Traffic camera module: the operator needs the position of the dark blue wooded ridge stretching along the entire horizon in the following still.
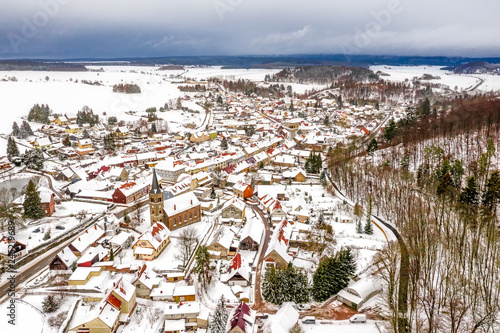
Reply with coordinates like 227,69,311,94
4,54,500,73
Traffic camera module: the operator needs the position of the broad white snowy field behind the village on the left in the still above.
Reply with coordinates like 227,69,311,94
0,66,278,133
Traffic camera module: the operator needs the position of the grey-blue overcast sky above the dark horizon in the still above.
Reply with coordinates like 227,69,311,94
0,0,500,58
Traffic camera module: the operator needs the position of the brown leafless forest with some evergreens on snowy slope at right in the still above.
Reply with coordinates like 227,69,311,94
329,96,500,332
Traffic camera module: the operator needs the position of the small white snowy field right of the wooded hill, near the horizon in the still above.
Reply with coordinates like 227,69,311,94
370,65,500,91
